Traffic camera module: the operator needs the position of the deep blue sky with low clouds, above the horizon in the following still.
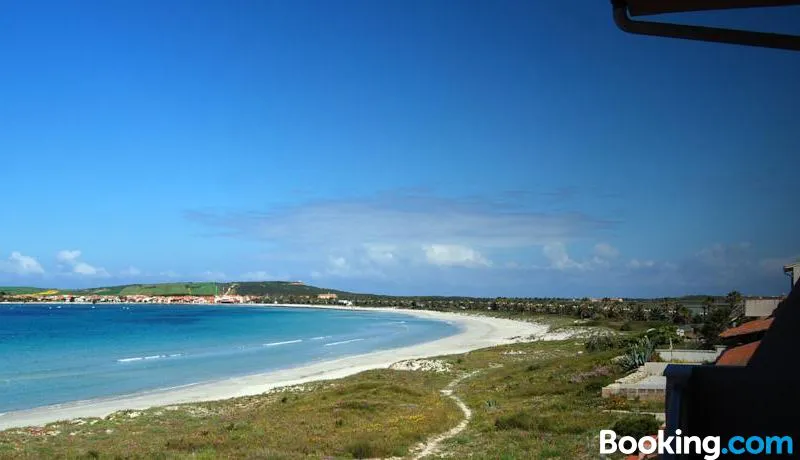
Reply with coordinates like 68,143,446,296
0,0,800,296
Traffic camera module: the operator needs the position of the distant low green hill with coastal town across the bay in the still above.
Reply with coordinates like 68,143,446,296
0,281,353,297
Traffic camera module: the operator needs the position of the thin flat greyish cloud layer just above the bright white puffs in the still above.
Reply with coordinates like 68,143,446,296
186,191,611,254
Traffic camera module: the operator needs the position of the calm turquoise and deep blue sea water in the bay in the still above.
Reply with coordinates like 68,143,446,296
0,304,458,412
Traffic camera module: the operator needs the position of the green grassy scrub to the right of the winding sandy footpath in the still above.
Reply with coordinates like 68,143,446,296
444,341,630,459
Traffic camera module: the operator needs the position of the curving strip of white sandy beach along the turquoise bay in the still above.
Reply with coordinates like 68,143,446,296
0,305,548,430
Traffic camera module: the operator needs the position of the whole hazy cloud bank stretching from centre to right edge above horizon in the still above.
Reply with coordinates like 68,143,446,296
181,194,797,295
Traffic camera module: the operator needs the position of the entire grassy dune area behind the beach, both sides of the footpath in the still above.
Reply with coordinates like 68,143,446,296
0,340,659,459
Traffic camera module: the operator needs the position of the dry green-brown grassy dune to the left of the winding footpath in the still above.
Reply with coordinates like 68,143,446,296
0,370,461,459
